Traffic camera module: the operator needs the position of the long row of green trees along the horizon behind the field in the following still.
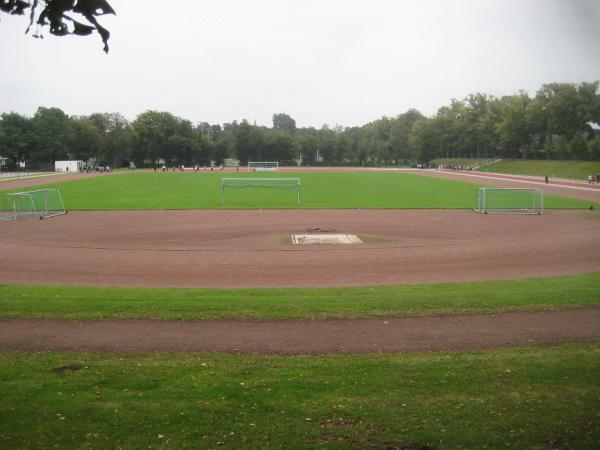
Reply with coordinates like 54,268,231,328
0,81,600,168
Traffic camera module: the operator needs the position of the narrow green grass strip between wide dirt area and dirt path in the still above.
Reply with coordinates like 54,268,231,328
0,273,600,320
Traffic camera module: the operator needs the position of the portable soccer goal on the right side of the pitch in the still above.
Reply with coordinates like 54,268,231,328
475,188,544,214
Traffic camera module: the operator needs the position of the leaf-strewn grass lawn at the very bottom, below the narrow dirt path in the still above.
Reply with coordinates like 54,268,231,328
0,344,600,449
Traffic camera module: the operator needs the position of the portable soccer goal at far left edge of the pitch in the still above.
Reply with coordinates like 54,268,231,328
0,189,67,220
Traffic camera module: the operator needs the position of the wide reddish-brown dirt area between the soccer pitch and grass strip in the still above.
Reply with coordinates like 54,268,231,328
0,210,600,287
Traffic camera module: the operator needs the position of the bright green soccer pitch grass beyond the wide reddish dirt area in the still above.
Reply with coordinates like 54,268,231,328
1,172,600,210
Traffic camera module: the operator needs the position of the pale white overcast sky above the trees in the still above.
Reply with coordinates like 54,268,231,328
0,0,600,127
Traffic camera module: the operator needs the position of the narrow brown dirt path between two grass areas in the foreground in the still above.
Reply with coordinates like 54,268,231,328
0,308,600,355
